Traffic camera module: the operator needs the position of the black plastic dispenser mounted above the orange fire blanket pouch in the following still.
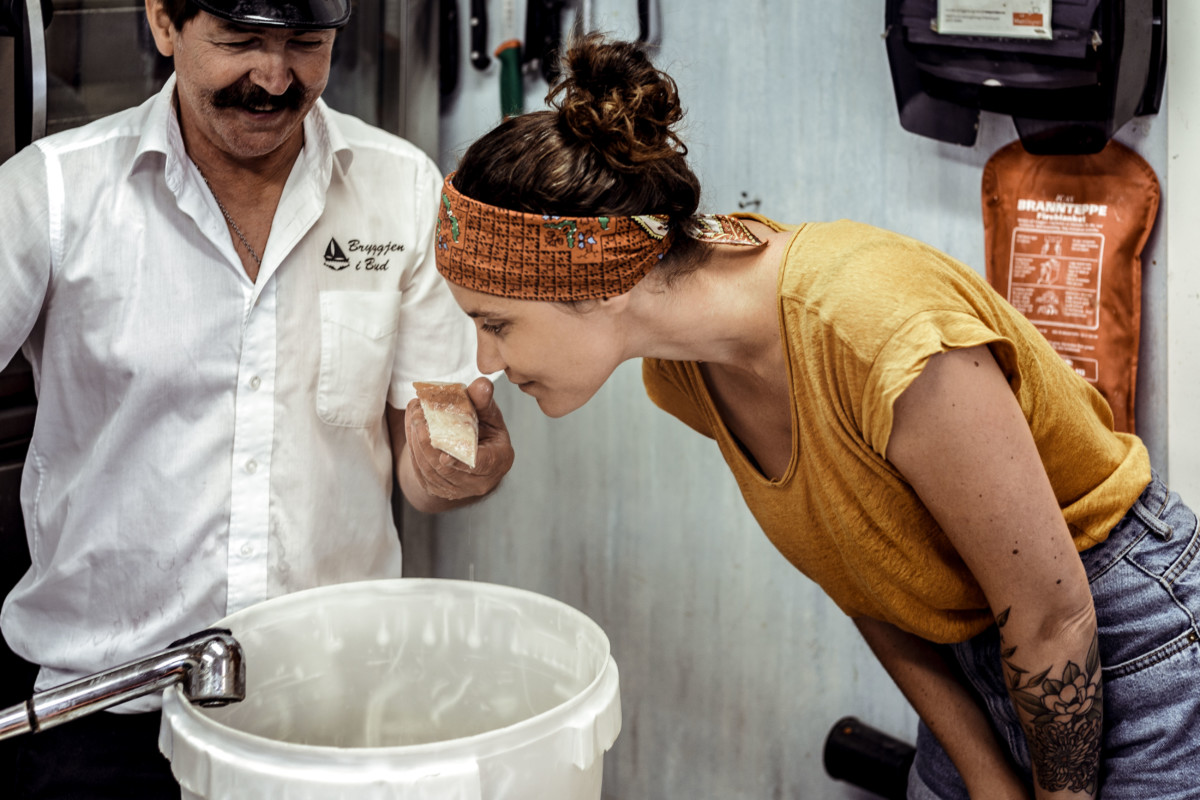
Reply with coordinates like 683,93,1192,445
884,0,1166,155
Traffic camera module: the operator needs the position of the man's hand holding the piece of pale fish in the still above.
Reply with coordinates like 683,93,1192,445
389,378,514,512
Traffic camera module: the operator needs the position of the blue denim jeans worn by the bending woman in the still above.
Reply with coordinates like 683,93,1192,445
908,475,1200,800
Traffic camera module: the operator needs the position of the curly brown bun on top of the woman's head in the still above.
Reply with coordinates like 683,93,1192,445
547,34,688,170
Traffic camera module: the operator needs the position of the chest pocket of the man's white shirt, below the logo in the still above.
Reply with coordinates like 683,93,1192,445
317,291,401,428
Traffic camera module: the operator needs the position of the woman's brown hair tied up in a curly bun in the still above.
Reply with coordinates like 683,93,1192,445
454,34,708,278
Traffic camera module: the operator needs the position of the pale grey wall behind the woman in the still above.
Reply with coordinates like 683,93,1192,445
404,0,1180,800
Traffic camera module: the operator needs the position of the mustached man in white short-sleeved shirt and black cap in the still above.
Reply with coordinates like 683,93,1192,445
0,0,512,798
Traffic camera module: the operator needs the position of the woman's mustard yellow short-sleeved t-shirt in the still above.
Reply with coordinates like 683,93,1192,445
642,217,1151,642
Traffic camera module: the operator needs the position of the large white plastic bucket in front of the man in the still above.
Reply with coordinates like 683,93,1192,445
160,578,620,800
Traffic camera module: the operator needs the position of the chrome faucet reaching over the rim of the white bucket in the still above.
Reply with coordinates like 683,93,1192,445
0,628,246,739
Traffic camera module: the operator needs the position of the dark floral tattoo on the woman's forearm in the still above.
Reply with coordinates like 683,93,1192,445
996,608,1103,794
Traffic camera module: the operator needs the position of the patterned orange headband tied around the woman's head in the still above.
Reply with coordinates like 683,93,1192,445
436,174,763,301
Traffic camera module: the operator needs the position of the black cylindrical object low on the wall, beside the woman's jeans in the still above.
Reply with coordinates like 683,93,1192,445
824,717,917,800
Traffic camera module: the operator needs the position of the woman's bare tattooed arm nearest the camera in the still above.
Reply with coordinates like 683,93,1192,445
887,347,1102,798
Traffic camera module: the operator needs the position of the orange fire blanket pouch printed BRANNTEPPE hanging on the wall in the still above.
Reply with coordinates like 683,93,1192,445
983,142,1159,433
